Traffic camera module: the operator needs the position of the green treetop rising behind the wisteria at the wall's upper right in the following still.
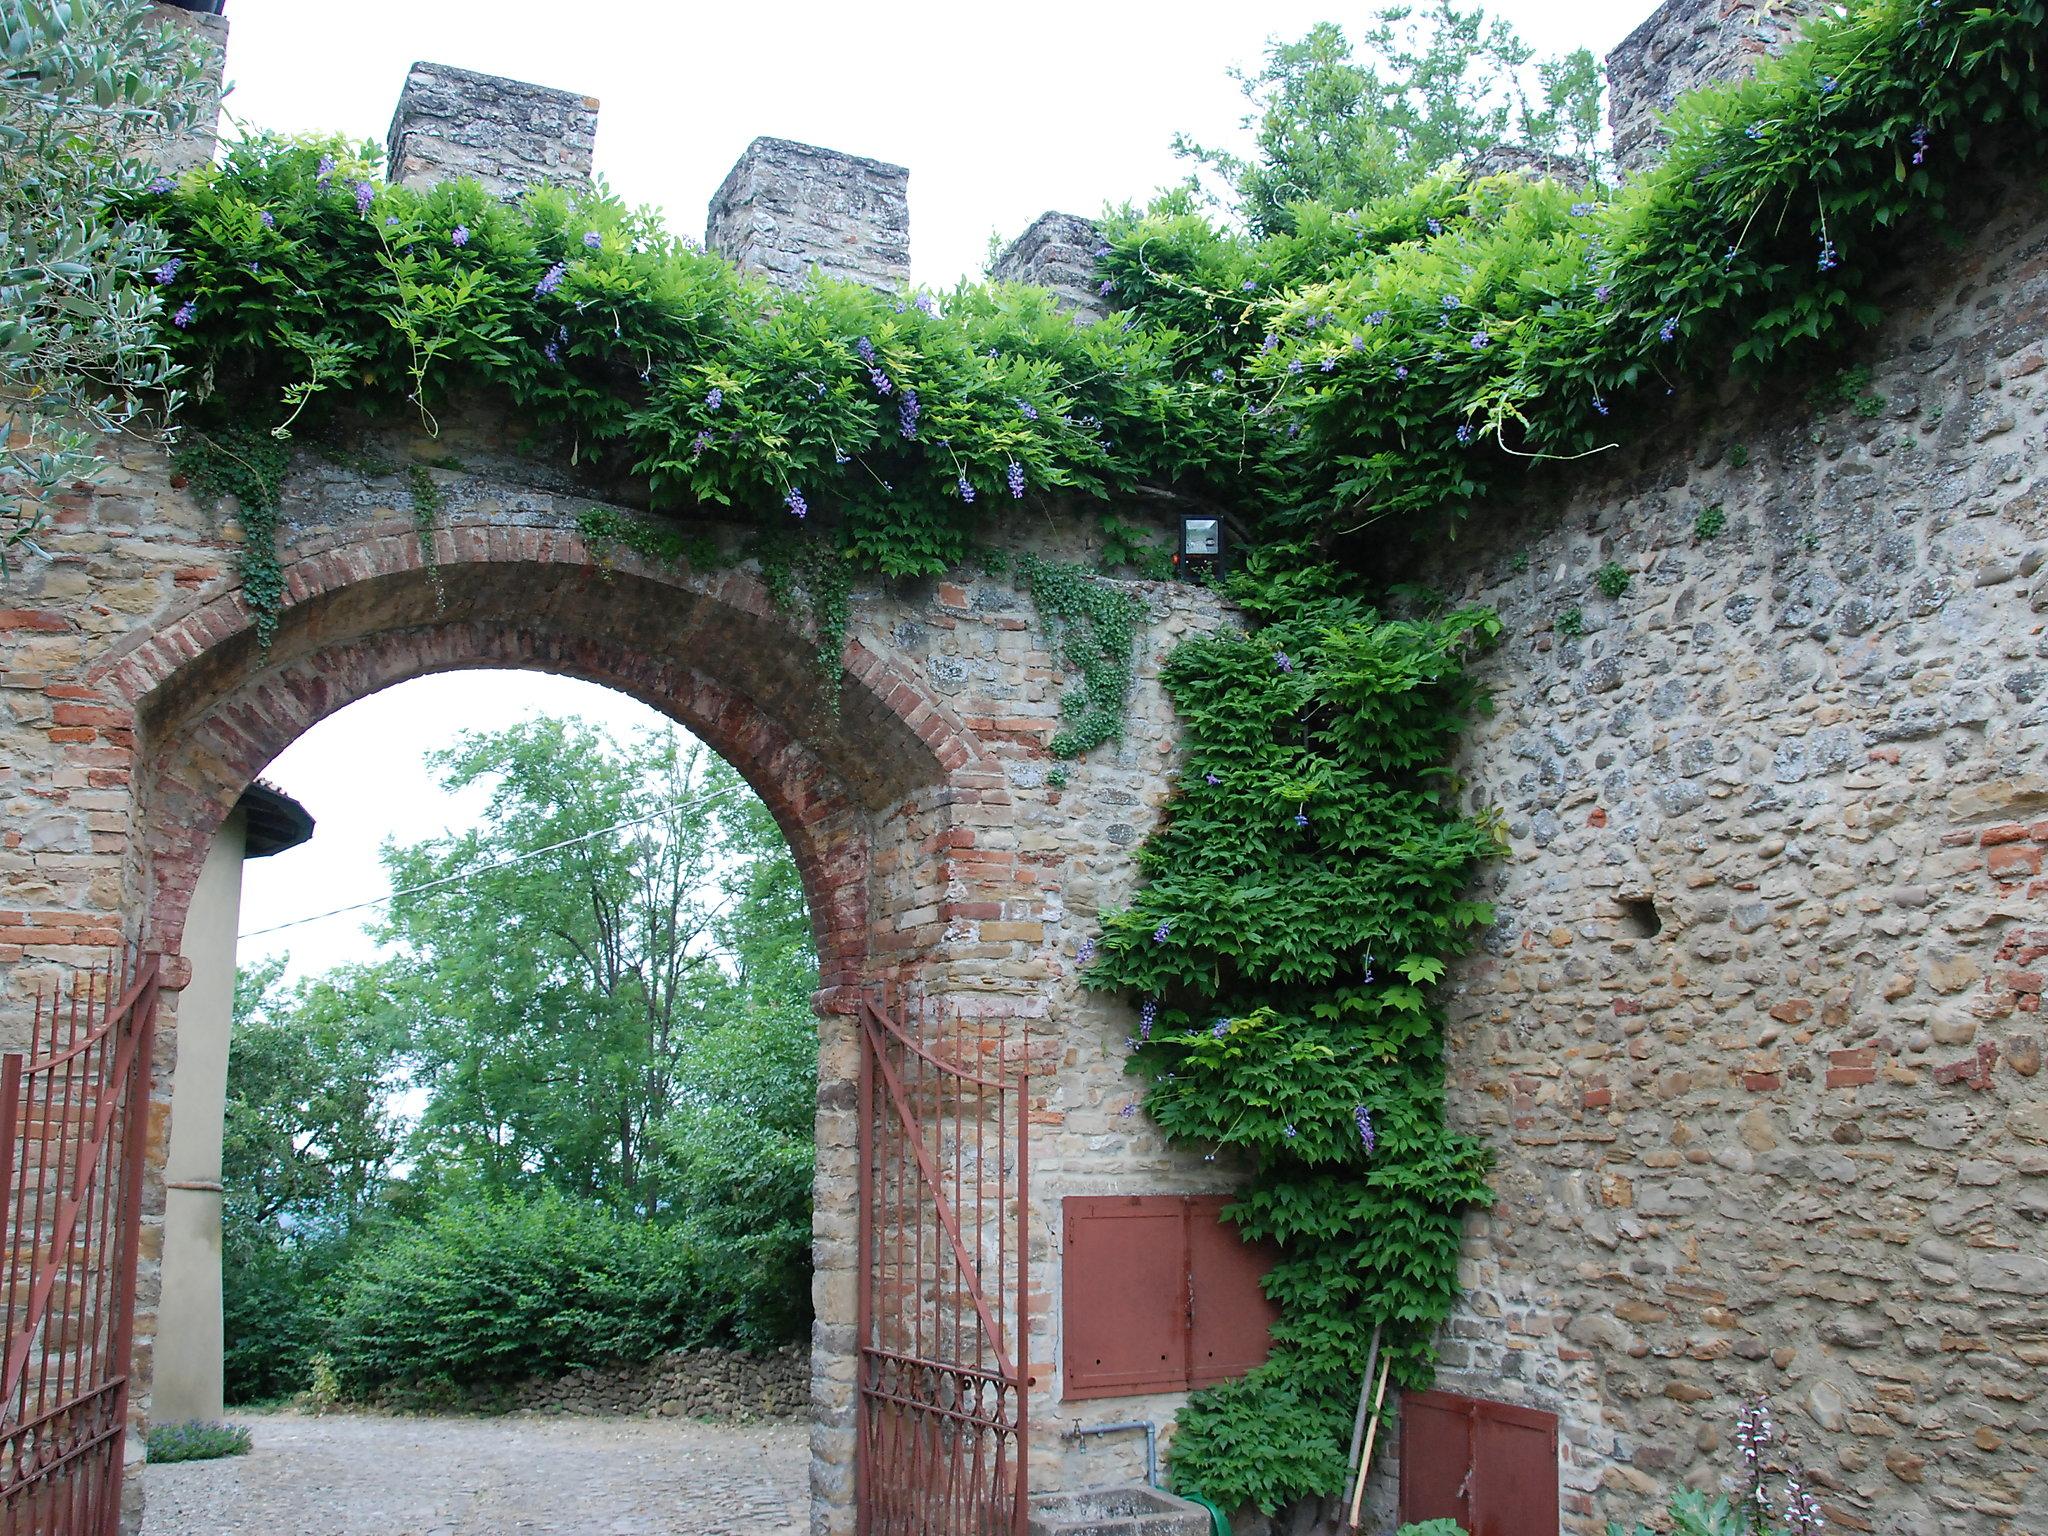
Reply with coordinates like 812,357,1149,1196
1174,0,1599,236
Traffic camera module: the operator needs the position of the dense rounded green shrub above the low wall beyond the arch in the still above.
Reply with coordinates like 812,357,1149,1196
330,1194,737,1393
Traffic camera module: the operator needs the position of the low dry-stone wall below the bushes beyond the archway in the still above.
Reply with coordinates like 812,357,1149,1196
504,1348,811,1419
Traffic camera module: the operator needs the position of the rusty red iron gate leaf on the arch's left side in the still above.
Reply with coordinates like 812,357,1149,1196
0,950,158,1536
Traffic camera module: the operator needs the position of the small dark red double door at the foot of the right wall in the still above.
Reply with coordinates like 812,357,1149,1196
1401,1393,1559,1536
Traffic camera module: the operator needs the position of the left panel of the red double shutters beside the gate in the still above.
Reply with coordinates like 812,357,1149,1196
1061,1194,1188,1397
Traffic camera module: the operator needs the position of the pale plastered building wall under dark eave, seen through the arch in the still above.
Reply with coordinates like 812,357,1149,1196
150,809,248,1423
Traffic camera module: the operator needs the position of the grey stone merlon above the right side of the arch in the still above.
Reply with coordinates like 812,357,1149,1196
705,139,909,291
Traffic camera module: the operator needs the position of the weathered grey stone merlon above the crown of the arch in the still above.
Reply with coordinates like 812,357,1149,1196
385,63,598,203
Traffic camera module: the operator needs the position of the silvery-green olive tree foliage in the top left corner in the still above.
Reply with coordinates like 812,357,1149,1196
0,0,219,565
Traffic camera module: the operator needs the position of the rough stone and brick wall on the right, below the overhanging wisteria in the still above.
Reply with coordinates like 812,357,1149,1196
1409,180,2048,1536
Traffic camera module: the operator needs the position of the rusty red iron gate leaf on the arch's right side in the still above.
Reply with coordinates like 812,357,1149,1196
856,999,1030,1536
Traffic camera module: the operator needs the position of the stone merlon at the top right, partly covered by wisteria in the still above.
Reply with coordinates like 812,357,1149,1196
1608,0,1823,172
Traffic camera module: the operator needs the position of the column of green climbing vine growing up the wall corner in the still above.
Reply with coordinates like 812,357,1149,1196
1085,584,1501,1511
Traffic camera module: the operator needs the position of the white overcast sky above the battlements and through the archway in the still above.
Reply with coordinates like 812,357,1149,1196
227,0,1653,975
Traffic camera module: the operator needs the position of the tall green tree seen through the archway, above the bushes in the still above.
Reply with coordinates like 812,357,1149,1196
385,721,815,1217
